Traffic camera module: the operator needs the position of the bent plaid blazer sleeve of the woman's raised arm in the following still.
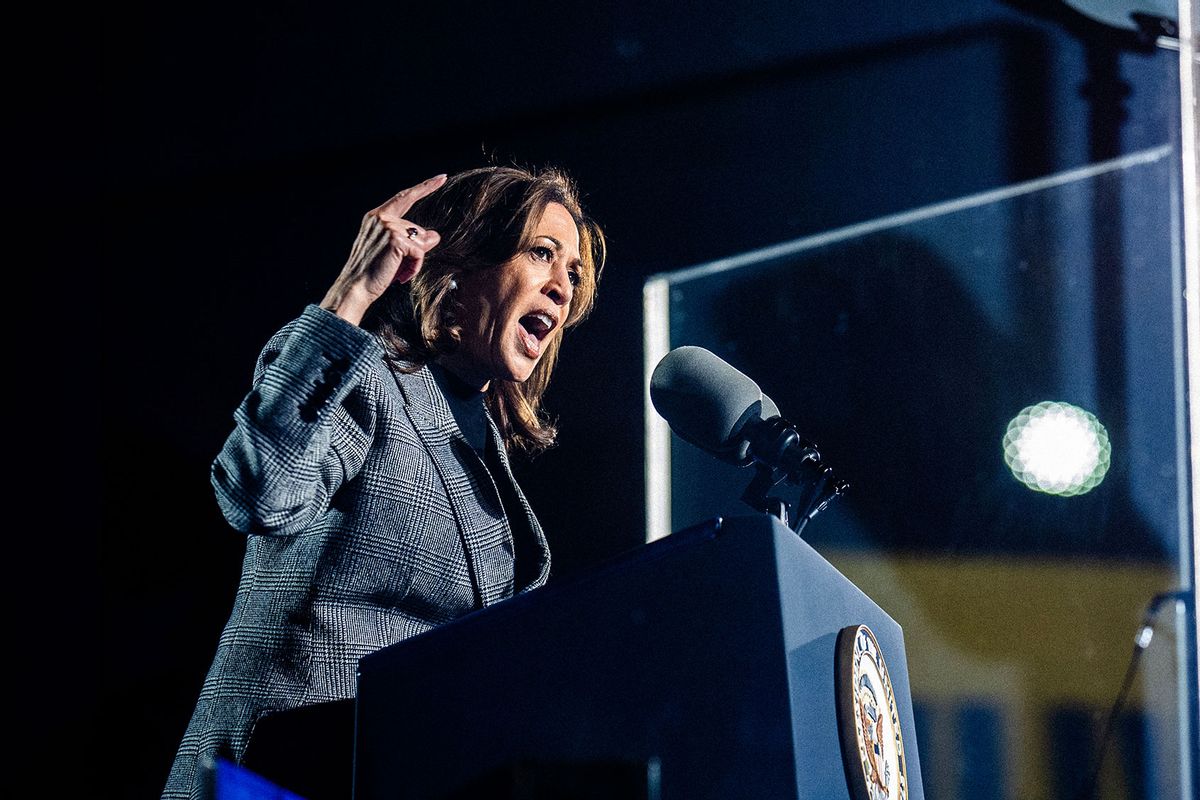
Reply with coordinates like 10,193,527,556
211,305,383,536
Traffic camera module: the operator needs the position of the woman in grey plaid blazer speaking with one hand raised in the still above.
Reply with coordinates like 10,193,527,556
163,167,605,798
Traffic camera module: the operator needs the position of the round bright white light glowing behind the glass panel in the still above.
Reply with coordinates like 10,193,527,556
1004,401,1112,497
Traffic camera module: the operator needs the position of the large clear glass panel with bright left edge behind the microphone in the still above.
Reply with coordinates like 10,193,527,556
646,148,1195,800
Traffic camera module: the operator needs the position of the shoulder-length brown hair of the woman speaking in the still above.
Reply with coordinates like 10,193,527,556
362,167,606,456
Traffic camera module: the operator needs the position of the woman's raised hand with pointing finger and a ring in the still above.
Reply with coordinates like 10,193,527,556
320,175,446,325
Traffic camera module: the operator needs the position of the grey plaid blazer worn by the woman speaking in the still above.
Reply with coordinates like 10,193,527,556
162,306,550,798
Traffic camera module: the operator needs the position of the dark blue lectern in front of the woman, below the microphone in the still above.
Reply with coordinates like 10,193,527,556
354,516,924,800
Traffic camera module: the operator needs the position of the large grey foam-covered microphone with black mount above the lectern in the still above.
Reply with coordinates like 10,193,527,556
650,345,821,475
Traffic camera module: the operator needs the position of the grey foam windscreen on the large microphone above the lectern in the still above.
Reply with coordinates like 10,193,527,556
650,345,763,464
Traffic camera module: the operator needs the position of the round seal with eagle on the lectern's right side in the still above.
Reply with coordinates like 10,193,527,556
834,625,908,800
